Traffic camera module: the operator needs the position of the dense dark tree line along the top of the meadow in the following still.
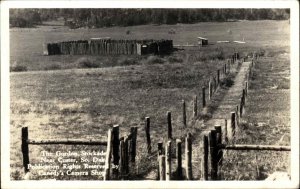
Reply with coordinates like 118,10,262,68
10,9,290,28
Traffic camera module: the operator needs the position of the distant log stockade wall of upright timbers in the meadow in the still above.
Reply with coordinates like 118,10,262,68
43,39,173,55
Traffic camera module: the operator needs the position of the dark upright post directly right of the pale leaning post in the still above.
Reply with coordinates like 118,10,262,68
112,125,120,178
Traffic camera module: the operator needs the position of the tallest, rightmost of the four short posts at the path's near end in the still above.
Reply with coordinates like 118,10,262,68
185,133,193,180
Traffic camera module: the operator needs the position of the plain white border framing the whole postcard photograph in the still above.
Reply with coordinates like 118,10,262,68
1,0,299,189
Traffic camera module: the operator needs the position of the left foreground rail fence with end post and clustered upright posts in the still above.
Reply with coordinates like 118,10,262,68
21,125,137,180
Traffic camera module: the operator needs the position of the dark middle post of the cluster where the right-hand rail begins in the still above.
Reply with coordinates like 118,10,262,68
208,130,218,180
